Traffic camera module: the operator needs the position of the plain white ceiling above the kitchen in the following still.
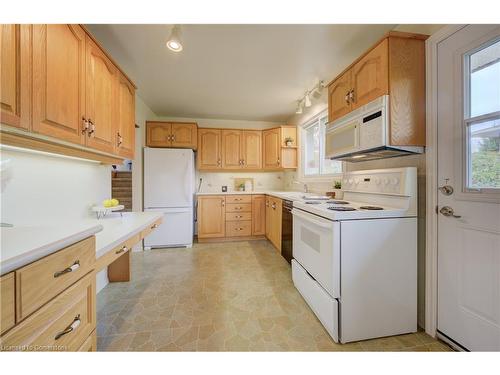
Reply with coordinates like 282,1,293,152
88,25,395,121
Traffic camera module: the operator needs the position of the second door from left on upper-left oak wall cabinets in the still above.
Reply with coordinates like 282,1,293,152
32,24,86,144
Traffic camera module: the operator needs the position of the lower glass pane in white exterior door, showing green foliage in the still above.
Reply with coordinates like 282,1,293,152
467,118,500,189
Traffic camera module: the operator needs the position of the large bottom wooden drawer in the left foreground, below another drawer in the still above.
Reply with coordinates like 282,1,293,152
0,272,96,351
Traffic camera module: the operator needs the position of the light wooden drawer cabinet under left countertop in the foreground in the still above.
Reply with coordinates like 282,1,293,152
0,236,96,351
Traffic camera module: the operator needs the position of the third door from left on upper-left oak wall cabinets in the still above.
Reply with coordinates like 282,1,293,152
85,36,118,153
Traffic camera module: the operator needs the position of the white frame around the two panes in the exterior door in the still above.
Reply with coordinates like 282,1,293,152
462,38,500,195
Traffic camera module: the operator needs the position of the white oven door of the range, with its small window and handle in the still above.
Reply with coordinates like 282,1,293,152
292,209,340,298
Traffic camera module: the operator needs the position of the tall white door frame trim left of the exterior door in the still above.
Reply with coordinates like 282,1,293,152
425,25,467,337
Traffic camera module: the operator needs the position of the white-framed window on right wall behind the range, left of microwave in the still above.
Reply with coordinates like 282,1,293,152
300,111,342,177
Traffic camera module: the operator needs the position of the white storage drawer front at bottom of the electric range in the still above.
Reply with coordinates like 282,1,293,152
292,259,339,342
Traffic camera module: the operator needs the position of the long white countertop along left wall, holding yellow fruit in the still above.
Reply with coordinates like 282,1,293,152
0,212,162,275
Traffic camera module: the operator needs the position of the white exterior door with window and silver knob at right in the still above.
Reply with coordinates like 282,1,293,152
437,25,500,351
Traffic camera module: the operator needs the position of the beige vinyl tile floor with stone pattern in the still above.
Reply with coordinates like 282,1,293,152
97,241,451,351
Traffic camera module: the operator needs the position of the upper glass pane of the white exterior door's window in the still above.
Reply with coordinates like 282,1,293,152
469,40,500,117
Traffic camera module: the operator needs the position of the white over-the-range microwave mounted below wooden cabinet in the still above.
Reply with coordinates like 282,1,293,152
325,95,424,162
